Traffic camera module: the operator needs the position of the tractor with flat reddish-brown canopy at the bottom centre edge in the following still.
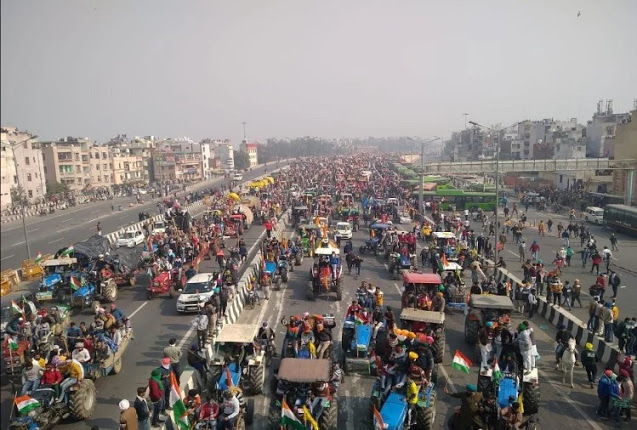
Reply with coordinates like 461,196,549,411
267,358,338,430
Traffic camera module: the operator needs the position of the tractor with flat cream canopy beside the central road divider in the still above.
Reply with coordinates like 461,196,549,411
208,324,266,399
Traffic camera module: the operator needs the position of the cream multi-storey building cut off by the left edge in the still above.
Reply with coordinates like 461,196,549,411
0,127,46,208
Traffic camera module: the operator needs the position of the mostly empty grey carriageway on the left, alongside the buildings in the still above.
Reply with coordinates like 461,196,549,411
0,162,284,270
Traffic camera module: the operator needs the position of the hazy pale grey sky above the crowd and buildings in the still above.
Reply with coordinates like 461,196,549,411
1,0,637,143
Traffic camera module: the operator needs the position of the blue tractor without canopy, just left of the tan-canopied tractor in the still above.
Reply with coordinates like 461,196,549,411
341,316,375,375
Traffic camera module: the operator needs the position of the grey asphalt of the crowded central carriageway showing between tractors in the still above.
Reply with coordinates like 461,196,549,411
227,220,607,430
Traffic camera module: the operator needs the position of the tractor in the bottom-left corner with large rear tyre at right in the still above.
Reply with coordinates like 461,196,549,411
8,379,97,430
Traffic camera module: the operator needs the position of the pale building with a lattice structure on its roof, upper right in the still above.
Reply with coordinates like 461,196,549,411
586,100,630,158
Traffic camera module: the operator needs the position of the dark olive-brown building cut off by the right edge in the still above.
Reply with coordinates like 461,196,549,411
613,110,637,205
